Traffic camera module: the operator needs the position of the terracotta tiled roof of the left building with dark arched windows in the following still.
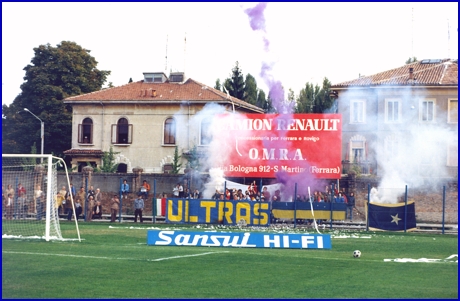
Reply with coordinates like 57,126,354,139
64,78,263,113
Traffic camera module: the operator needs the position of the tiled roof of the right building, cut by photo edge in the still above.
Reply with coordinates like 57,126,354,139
331,59,458,88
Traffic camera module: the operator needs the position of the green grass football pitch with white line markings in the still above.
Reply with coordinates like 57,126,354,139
2,222,458,299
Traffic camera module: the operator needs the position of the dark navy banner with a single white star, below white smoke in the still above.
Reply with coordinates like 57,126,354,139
368,201,417,231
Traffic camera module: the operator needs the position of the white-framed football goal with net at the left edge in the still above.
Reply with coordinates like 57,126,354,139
2,154,80,241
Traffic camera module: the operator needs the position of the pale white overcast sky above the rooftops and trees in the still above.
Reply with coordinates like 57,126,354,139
2,2,458,105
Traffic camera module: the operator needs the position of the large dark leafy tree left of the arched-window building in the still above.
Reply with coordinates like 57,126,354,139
2,41,110,157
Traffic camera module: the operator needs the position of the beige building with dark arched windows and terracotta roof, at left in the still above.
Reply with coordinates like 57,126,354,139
64,72,263,173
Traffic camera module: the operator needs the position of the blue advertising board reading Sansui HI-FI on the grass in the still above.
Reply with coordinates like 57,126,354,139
147,230,332,249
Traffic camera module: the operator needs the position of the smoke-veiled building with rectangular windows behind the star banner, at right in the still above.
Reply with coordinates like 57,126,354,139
331,59,458,179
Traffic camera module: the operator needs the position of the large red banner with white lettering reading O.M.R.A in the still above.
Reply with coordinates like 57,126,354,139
213,114,342,179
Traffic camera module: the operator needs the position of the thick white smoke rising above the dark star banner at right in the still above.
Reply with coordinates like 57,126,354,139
339,83,458,203
